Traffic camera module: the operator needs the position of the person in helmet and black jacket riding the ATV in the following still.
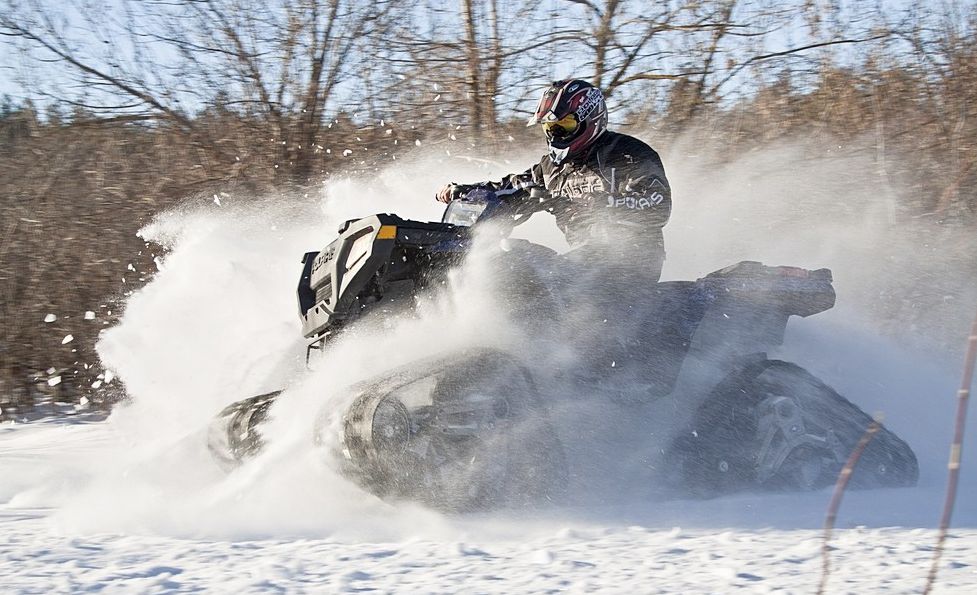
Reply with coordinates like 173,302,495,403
437,79,672,283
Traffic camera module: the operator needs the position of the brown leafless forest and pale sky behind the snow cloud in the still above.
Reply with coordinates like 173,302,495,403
0,0,977,417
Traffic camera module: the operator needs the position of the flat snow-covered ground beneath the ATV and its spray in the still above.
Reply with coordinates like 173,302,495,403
0,422,977,593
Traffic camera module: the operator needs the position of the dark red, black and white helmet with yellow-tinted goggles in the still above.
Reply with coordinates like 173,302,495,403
527,79,607,165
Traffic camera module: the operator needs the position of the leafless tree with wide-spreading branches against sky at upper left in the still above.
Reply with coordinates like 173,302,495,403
0,0,391,181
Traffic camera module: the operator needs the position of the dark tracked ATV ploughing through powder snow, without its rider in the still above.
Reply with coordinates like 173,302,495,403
209,191,918,510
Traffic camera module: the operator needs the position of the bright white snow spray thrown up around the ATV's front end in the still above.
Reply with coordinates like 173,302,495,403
49,150,548,538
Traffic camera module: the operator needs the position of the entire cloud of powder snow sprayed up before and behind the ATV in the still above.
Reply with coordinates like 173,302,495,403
36,140,977,540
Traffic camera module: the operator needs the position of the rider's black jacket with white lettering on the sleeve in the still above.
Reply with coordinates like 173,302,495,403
485,131,672,258
